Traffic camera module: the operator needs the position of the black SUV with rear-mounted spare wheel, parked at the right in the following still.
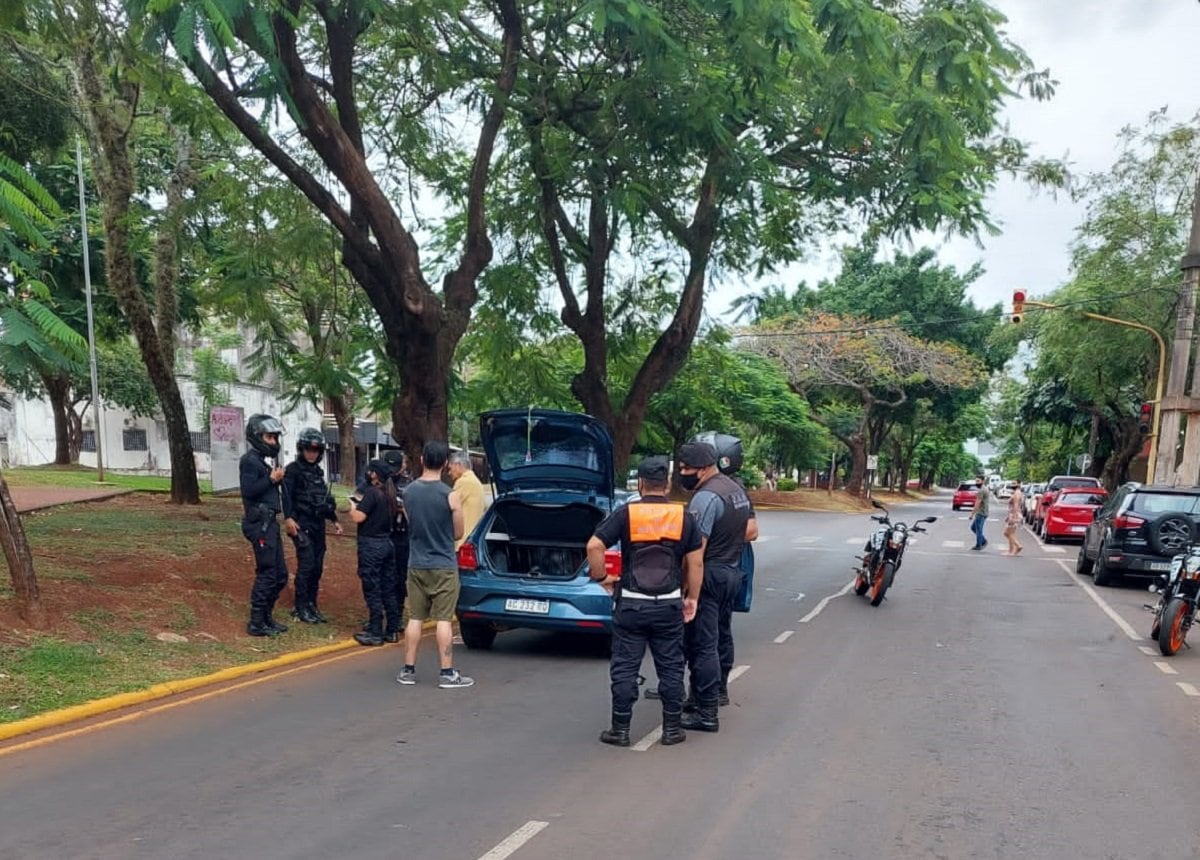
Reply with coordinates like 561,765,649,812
1075,483,1200,585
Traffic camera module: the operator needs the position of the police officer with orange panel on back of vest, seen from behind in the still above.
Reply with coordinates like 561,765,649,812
587,457,703,746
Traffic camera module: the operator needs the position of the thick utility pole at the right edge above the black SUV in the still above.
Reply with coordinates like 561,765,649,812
1156,176,1200,487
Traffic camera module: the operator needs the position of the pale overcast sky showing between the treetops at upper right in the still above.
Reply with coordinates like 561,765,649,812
708,0,1200,317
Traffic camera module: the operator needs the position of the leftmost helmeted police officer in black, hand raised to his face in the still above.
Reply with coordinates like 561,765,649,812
238,415,288,636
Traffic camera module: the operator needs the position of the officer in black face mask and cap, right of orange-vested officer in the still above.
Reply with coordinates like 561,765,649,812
676,441,750,732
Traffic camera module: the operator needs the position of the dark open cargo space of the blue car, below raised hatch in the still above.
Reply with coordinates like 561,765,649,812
482,499,605,579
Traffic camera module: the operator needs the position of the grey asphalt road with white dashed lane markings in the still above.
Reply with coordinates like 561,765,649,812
0,497,1200,860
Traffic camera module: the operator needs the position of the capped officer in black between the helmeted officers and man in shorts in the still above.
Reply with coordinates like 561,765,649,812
350,459,400,645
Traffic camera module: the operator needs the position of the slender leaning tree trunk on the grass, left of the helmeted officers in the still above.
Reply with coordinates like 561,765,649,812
76,44,200,505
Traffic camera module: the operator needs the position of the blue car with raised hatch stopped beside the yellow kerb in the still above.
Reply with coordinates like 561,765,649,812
457,409,625,649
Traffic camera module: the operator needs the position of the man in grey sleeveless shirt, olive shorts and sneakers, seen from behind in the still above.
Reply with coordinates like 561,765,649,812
396,441,475,690
